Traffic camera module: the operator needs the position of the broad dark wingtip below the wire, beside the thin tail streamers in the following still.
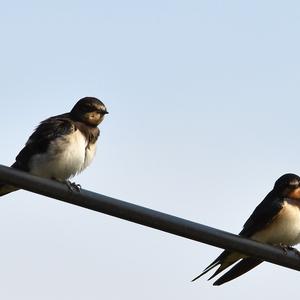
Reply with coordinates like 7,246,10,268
213,257,263,285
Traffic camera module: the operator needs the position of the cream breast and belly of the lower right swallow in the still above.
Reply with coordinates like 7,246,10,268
251,200,300,246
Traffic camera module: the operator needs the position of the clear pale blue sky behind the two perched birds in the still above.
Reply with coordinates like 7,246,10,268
0,0,300,300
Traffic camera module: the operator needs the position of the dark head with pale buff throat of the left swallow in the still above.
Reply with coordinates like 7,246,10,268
71,97,108,126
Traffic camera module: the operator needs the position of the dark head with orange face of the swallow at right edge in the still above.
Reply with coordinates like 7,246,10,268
273,173,300,200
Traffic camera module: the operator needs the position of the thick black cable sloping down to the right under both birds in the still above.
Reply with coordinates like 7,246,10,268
0,165,300,271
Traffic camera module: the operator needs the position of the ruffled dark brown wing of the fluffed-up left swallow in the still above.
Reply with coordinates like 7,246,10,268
12,114,76,171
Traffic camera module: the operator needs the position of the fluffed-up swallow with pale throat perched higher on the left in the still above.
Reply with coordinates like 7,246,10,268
0,97,108,196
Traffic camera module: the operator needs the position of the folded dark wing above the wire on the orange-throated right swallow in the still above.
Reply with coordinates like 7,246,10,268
240,191,283,237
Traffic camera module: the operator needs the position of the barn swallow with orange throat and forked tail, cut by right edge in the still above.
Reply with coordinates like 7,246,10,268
192,174,300,285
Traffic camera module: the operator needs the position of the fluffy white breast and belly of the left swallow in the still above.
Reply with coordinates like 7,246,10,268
30,130,96,181
